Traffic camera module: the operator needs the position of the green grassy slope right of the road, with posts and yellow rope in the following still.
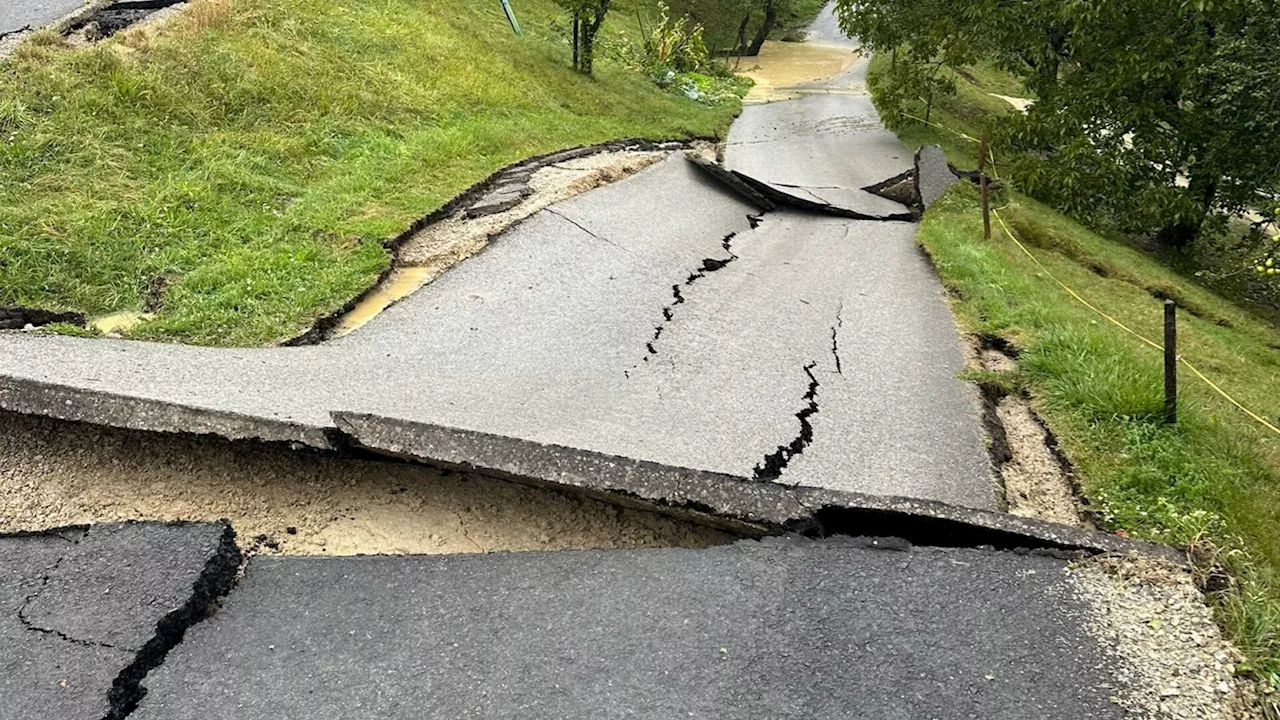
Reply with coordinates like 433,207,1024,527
873,51,1280,697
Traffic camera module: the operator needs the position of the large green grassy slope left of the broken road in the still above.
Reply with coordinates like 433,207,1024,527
0,0,737,345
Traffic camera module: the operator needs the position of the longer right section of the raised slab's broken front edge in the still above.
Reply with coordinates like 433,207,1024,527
333,413,1185,564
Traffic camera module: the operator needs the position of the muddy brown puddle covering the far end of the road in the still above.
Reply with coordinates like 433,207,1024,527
739,40,859,102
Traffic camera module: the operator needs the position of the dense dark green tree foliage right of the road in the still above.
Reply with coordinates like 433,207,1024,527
838,0,1280,247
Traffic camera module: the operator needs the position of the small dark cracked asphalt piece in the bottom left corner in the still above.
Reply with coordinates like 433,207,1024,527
0,523,239,720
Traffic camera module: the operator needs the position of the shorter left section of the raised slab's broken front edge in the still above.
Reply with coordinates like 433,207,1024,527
0,375,342,450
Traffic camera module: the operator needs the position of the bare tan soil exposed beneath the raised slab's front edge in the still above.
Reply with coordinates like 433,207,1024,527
0,413,735,555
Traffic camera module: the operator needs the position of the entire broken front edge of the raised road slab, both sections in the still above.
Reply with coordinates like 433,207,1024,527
0,375,1185,564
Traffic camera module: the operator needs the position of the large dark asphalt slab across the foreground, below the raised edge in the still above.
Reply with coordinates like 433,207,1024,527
133,538,1123,720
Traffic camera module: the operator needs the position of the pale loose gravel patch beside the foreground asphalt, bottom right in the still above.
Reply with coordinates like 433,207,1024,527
1070,556,1262,720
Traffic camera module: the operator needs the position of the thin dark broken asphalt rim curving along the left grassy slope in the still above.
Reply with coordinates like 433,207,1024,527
279,136,717,347
